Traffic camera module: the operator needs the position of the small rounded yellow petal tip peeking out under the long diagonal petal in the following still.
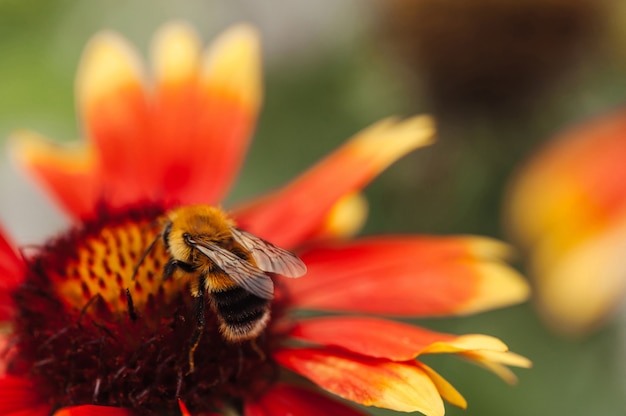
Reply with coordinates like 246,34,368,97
319,193,368,238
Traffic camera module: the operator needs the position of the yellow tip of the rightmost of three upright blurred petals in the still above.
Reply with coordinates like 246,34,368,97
202,24,263,113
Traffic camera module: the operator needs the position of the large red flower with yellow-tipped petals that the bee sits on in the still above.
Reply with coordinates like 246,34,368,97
0,23,529,416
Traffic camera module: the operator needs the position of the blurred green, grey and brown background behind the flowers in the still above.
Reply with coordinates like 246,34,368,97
0,0,626,416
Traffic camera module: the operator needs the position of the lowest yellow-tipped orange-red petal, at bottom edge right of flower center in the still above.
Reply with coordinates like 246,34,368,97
275,348,444,416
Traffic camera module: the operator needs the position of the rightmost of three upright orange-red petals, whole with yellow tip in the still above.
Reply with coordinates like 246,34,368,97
170,25,263,204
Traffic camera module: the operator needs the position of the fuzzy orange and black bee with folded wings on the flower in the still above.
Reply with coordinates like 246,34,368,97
135,205,306,372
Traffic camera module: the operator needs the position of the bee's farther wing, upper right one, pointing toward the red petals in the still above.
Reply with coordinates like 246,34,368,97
231,227,306,277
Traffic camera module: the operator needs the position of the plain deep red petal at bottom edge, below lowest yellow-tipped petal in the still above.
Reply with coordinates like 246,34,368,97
244,384,365,416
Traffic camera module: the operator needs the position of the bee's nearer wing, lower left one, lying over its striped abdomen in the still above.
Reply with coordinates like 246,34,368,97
190,240,274,299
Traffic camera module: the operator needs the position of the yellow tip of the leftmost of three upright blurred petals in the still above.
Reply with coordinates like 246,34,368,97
76,31,145,113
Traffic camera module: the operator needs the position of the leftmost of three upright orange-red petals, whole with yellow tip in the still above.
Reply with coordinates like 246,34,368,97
76,28,149,214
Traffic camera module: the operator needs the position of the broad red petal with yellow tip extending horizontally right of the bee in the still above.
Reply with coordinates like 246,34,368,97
284,237,529,316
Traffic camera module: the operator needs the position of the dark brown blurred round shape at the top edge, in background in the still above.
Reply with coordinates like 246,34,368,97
378,0,604,118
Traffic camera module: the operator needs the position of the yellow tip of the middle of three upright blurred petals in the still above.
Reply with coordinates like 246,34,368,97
151,22,201,83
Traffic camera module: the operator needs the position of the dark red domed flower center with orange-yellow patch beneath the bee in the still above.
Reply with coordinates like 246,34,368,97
9,207,282,413
